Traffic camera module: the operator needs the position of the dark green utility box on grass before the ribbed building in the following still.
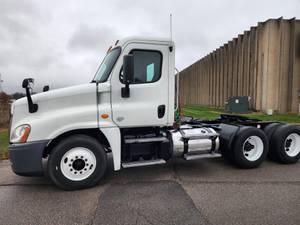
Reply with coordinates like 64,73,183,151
225,96,250,113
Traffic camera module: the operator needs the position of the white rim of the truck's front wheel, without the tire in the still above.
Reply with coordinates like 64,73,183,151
60,147,96,181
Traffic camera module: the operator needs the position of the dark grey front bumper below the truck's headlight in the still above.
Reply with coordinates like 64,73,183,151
9,140,49,176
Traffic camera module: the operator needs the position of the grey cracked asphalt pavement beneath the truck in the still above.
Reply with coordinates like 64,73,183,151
0,158,300,225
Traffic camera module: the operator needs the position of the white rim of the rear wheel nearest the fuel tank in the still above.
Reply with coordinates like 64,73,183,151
243,136,264,162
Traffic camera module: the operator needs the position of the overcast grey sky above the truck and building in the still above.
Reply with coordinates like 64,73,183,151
0,0,300,93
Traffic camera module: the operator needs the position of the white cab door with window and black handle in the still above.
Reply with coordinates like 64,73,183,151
111,43,169,127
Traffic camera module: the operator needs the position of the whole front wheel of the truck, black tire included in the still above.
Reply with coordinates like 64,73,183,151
47,135,107,191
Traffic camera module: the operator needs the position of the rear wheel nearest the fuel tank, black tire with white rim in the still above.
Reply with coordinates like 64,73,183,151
232,127,269,169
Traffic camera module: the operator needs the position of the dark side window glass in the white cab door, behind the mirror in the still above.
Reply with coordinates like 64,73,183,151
120,50,162,84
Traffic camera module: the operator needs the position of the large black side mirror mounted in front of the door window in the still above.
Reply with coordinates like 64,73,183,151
121,55,134,98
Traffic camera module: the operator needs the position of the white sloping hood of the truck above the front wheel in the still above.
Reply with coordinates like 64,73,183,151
11,82,110,141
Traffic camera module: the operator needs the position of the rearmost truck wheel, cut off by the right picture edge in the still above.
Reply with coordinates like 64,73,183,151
270,125,300,164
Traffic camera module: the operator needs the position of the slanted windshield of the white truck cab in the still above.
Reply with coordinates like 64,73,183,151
93,47,121,83
